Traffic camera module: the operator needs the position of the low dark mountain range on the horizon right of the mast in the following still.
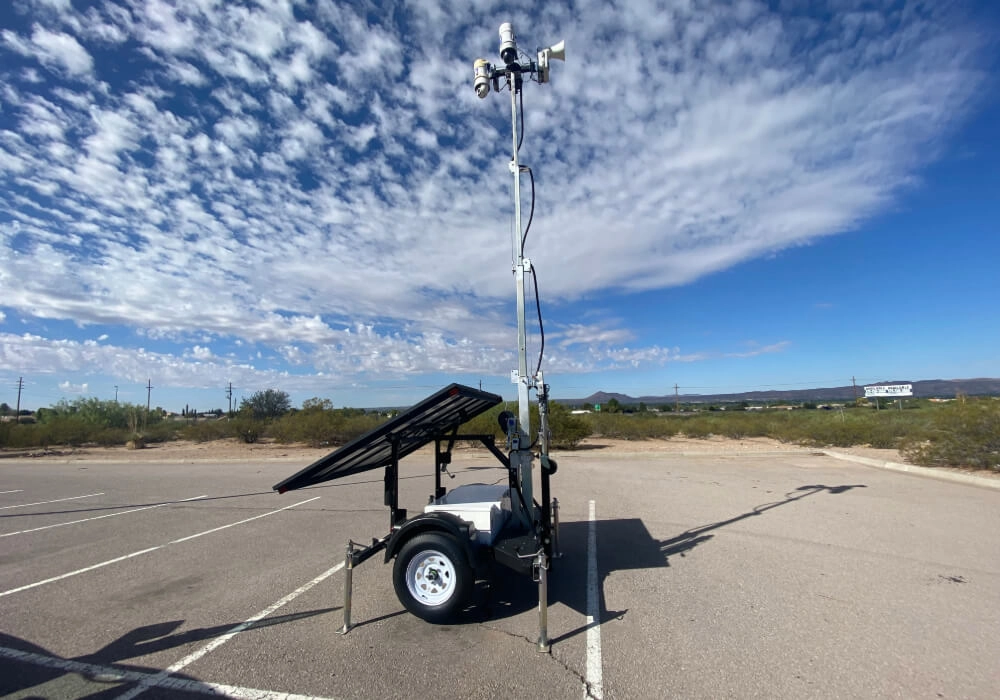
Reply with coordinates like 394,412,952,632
558,379,1000,406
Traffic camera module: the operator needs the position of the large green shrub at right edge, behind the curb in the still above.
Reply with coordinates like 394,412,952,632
903,399,1000,470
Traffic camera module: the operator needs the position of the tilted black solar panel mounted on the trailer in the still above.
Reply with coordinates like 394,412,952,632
274,384,503,493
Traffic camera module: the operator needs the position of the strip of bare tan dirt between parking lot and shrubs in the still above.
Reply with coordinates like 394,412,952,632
0,437,905,464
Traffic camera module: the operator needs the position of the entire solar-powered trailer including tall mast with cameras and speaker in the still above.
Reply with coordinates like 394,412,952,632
274,23,566,652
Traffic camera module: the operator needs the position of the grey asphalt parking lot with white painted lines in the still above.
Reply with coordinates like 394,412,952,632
0,449,1000,698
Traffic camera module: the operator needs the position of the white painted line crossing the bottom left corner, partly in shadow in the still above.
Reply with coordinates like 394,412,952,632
0,647,329,700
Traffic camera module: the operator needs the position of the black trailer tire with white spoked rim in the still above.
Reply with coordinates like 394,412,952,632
392,532,474,623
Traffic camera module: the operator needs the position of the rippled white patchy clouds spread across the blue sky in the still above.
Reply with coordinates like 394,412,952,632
0,0,983,388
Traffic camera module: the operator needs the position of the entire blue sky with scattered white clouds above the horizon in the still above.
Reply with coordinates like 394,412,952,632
0,0,1000,410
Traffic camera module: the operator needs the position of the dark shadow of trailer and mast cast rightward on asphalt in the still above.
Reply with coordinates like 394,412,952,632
458,484,867,642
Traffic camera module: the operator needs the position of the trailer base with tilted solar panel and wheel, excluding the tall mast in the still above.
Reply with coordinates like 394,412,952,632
274,384,555,644
